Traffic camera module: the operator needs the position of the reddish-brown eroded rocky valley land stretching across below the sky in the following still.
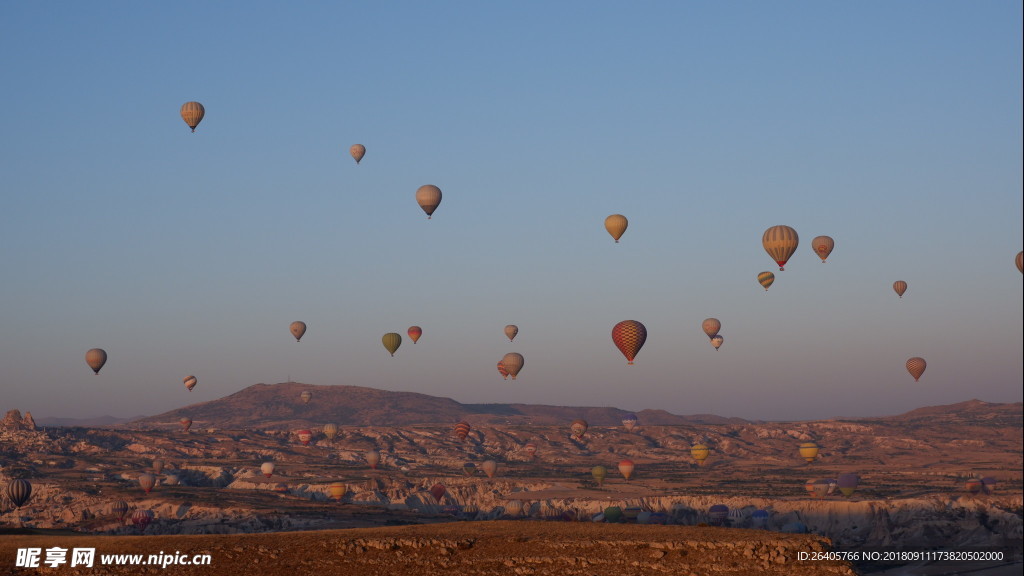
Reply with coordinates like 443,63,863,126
0,383,1024,574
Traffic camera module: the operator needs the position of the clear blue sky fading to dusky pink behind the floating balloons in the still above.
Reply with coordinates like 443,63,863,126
0,0,1024,420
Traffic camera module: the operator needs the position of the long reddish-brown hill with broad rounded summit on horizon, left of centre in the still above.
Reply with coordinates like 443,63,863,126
132,382,746,428
